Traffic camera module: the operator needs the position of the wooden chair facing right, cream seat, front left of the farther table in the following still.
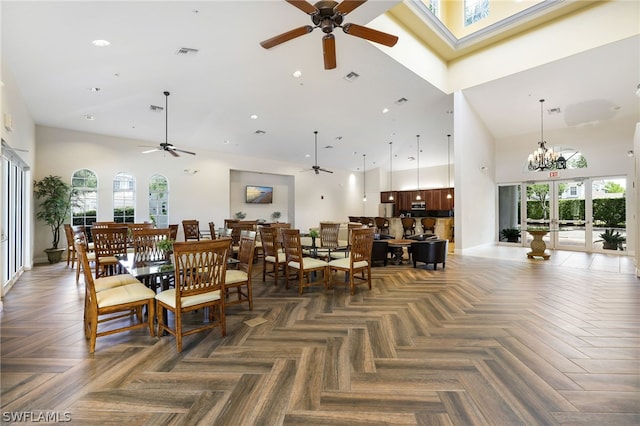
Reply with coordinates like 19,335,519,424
281,229,329,295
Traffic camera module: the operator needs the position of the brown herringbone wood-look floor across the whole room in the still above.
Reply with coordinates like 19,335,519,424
1,255,640,425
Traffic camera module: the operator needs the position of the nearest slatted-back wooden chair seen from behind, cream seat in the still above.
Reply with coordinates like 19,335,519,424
156,239,229,352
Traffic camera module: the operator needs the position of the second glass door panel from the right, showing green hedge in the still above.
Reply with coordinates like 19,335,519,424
550,179,591,251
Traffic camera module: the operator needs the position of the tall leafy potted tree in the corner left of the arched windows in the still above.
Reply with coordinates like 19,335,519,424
33,175,75,263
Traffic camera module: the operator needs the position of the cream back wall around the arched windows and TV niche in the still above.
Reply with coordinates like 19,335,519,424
33,126,364,261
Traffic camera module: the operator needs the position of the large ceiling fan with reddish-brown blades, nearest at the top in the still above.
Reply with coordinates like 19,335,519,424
260,0,398,70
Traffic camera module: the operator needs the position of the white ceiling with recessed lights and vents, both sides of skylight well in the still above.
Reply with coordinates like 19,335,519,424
1,0,640,170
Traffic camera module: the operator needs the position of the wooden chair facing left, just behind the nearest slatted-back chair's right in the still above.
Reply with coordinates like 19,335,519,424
224,235,256,311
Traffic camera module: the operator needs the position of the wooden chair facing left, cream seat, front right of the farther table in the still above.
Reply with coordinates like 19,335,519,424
329,228,373,296
